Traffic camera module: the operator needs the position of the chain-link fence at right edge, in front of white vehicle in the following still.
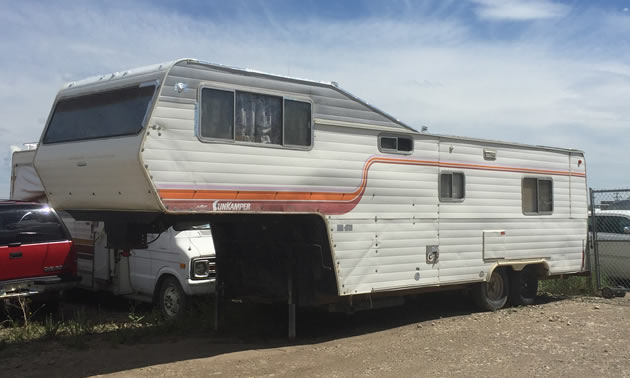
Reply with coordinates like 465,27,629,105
589,189,630,297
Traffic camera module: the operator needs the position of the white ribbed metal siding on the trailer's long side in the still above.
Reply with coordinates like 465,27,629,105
142,65,586,295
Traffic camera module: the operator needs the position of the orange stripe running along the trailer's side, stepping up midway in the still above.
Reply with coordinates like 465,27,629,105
158,157,586,201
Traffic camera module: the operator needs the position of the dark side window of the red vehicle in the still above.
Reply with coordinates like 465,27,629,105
0,205,67,245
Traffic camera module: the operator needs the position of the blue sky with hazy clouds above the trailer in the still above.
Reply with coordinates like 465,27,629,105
0,0,630,198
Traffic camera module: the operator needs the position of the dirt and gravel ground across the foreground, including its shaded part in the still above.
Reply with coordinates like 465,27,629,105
0,295,630,377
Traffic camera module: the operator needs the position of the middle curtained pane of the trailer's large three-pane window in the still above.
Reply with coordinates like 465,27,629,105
234,92,282,144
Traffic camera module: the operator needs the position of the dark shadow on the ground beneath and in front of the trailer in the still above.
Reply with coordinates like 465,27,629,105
0,292,562,377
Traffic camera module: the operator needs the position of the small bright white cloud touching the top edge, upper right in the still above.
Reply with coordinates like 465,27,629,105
472,0,569,21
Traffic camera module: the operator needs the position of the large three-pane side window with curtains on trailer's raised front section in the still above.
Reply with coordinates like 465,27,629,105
199,88,313,147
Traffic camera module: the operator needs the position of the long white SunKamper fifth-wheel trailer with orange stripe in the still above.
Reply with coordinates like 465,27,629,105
35,59,587,334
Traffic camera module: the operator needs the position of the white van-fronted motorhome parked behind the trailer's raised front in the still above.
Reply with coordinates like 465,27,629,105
11,149,215,318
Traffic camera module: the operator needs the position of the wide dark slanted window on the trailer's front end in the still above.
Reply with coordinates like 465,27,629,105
43,85,155,144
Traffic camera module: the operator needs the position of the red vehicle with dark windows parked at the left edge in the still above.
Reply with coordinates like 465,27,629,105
0,200,78,299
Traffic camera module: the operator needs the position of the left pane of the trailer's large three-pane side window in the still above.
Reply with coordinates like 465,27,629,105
201,88,234,139
